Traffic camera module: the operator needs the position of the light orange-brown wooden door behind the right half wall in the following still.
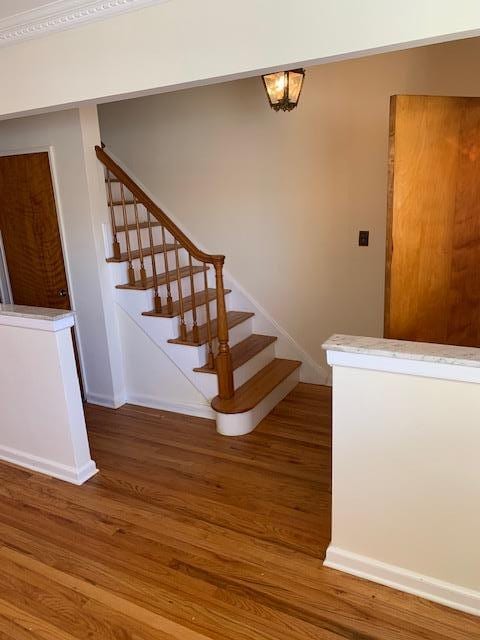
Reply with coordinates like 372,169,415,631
385,96,480,347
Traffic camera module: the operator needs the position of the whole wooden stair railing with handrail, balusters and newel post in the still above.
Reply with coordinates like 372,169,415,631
95,146,234,400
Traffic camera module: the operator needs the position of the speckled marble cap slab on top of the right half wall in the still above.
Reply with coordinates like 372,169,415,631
322,334,480,368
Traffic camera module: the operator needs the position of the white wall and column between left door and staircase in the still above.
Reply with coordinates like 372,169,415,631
0,107,124,404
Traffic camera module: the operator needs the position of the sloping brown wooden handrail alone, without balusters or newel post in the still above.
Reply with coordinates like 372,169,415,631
95,145,225,265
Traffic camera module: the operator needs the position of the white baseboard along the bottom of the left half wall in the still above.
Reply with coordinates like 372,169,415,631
0,446,98,485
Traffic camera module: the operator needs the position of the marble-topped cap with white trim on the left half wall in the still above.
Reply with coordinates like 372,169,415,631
0,304,75,332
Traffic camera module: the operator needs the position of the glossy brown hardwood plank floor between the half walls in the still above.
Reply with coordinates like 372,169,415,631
0,384,480,640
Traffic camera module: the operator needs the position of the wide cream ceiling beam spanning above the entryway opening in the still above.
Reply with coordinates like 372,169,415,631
0,0,480,115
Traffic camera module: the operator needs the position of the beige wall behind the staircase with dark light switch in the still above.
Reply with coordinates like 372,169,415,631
100,39,480,370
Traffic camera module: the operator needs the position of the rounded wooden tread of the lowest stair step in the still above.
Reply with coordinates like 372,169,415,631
212,358,302,413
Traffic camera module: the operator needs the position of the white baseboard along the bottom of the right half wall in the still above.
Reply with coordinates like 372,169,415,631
324,545,480,616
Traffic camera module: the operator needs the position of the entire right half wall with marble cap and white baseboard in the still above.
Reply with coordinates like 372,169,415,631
324,336,480,615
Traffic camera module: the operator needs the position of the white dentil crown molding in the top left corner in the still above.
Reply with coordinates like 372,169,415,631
0,0,168,47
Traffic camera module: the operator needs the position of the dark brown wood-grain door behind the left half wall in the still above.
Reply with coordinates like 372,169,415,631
0,153,70,309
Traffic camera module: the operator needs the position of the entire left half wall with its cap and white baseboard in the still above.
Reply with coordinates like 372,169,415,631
0,304,97,484
